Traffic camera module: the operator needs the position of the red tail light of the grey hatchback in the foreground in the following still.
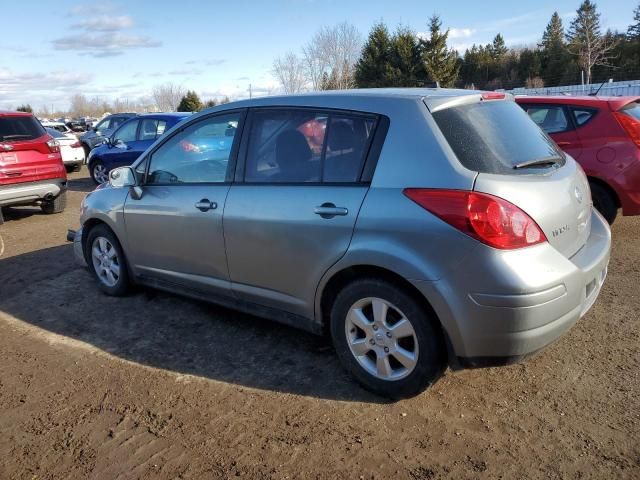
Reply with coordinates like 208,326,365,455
404,188,547,250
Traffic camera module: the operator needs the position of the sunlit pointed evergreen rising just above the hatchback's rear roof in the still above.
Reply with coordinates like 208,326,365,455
420,15,460,87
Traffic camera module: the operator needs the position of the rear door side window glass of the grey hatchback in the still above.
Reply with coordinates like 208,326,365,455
245,109,376,183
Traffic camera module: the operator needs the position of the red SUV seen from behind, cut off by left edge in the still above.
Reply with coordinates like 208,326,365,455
0,111,67,221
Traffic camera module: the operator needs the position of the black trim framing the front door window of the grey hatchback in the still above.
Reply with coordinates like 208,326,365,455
138,108,247,187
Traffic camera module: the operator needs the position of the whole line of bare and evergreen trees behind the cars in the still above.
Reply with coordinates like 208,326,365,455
272,0,640,93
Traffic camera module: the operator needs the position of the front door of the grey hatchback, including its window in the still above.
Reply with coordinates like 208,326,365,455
124,112,243,294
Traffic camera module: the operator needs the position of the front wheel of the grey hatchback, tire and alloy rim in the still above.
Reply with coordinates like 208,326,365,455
84,225,131,297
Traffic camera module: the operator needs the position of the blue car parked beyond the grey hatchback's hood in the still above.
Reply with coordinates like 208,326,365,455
87,113,191,184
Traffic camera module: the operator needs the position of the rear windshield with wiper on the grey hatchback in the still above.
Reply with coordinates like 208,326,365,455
433,101,565,174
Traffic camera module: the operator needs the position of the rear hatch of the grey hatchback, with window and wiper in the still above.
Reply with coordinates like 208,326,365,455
426,93,591,257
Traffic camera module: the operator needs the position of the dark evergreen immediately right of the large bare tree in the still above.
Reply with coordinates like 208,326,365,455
355,22,391,88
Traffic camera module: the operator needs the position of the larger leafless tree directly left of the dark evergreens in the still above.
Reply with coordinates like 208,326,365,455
302,22,362,90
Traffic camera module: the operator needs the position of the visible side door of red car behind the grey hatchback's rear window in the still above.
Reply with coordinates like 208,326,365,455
522,103,582,160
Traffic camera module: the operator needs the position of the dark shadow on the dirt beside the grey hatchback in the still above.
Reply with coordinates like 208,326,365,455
0,245,386,403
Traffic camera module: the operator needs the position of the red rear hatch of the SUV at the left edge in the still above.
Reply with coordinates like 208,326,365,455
0,113,66,185
